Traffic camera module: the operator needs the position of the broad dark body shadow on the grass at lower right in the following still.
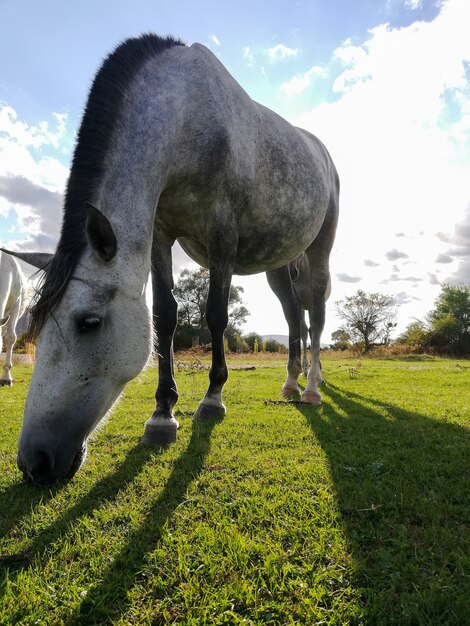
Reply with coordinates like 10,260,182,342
297,385,470,625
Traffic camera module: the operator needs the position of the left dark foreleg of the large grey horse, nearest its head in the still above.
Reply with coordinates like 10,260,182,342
143,236,179,445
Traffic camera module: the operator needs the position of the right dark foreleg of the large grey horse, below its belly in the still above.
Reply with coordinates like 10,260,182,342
194,269,232,419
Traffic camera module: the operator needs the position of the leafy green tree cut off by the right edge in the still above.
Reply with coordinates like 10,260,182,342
428,285,470,356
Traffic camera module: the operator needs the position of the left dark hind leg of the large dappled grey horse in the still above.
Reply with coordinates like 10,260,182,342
266,265,302,398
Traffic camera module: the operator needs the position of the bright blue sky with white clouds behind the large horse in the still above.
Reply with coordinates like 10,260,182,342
0,0,470,340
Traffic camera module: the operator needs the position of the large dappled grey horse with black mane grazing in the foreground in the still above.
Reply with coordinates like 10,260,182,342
6,35,339,481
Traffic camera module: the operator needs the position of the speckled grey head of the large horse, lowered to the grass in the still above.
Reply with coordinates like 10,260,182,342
18,208,151,482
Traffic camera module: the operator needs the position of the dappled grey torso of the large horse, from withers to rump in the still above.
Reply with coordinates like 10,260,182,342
157,44,332,274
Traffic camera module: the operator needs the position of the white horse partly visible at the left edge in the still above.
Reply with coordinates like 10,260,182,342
0,251,26,386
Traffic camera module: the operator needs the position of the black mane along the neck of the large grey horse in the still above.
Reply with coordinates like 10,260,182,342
29,34,185,340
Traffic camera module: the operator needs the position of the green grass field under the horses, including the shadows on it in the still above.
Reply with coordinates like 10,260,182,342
0,357,470,626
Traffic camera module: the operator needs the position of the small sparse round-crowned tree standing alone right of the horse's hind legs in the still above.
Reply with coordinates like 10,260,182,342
336,289,397,352
